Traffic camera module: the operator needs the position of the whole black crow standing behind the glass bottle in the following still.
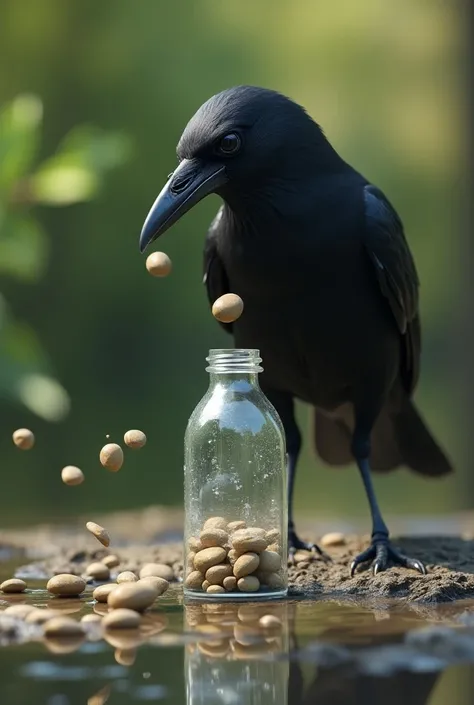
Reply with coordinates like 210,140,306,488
140,86,452,575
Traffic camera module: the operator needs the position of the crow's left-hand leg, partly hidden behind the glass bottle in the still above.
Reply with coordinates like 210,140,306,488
265,390,331,560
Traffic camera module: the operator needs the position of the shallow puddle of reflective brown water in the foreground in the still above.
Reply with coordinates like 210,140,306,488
0,564,474,705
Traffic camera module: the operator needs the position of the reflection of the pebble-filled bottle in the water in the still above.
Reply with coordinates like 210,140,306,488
185,603,289,705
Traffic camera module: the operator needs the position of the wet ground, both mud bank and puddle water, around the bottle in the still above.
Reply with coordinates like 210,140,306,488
0,508,474,705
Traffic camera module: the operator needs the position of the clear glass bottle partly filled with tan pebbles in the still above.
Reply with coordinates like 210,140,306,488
184,349,288,600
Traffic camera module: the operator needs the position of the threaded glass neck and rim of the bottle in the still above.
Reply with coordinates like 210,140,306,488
206,348,263,387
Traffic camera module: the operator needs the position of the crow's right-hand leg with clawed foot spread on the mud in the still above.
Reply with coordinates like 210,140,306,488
351,426,426,575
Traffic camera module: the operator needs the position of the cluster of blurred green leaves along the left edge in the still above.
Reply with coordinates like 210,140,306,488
0,95,131,421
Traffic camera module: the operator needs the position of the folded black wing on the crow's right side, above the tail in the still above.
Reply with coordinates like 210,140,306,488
364,184,421,393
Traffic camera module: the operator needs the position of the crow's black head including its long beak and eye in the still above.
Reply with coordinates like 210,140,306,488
140,86,328,252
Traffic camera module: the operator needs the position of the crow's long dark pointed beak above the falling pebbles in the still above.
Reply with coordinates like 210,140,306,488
140,159,227,252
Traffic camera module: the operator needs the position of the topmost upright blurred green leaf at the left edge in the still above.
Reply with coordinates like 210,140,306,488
0,94,43,191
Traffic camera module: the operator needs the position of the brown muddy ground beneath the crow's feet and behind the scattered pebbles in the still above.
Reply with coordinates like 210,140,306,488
0,507,474,602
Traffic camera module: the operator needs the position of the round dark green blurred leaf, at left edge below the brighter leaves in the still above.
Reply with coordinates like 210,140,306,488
0,212,49,282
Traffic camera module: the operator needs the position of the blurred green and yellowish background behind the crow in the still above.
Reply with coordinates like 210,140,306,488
0,0,466,525
